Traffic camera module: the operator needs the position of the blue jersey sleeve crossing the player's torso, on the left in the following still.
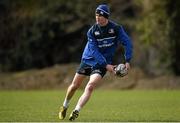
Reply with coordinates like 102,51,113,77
87,29,107,67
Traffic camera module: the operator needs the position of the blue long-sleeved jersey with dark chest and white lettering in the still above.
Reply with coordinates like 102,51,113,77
81,21,132,67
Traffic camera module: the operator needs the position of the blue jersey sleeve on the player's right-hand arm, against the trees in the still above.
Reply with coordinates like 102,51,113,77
118,26,133,62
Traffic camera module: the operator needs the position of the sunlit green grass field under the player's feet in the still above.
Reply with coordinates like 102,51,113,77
0,90,180,122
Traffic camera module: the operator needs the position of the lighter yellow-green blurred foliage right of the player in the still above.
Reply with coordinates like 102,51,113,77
136,0,172,74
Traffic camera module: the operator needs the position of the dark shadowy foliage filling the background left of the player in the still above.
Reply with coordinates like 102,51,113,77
0,0,133,71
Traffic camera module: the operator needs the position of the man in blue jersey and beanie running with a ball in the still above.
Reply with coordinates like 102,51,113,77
59,4,132,121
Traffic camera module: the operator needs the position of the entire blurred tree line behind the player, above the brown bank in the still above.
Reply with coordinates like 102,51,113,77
0,0,180,75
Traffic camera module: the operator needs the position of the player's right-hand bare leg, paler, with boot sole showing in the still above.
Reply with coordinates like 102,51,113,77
69,73,102,120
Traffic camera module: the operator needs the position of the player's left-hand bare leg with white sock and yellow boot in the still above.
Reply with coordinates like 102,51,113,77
59,73,85,119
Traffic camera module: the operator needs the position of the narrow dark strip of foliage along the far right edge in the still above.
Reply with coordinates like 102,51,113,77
167,0,180,75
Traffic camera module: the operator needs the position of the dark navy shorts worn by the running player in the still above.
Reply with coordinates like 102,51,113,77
76,62,107,77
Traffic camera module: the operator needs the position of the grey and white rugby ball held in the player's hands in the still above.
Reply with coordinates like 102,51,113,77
114,64,128,77
